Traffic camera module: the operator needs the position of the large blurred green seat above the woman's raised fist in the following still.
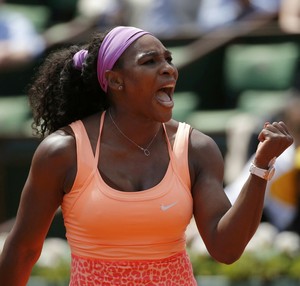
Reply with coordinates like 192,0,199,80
224,42,299,107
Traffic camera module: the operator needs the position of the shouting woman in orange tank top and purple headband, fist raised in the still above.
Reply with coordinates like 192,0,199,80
0,27,293,286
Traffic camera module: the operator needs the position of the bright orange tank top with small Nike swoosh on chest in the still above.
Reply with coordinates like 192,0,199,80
62,112,193,261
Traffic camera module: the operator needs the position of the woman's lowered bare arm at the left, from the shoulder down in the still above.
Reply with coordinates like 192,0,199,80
0,131,76,286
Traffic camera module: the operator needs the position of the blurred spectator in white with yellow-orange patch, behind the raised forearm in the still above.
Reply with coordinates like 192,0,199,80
225,94,300,234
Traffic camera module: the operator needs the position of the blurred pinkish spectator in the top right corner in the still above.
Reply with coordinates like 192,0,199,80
279,0,300,33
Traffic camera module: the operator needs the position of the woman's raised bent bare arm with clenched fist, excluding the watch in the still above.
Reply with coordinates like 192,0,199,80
190,120,293,263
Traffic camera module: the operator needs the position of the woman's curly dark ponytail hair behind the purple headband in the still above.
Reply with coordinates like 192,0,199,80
28,32,109,138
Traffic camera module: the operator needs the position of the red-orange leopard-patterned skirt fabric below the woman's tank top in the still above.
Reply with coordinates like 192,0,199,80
69,252,197,286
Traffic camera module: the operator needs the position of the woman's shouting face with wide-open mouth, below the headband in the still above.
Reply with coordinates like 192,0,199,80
113,35,178,122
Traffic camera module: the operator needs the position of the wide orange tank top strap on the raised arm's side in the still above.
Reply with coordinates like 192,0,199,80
165,122,191,189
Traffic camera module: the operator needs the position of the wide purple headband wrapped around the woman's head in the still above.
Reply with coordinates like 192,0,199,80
97,26,150,92
